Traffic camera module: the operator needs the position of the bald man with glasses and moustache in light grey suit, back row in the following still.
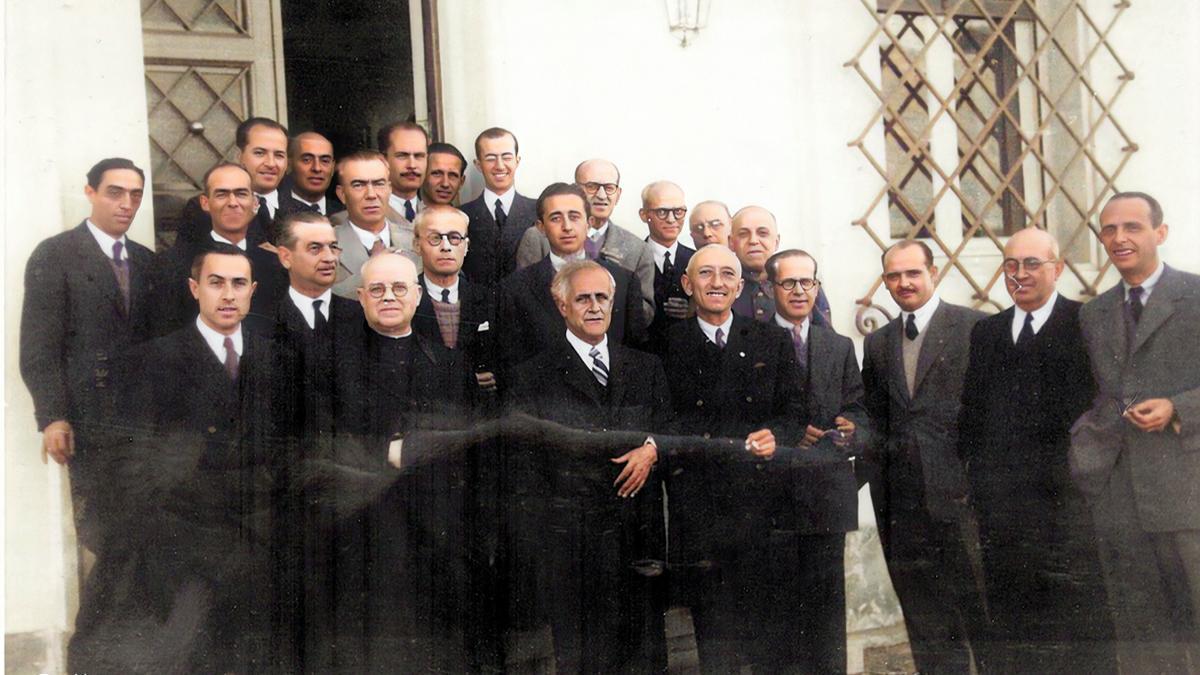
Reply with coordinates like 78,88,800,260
517,160,654,325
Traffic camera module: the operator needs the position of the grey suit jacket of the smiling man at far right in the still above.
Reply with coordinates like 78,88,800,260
1070,267,1200,532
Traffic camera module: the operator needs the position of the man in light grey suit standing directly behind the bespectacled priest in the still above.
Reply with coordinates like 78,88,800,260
330,150,421,299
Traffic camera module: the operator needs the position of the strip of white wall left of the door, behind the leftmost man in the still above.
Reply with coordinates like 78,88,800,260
4,0,154,648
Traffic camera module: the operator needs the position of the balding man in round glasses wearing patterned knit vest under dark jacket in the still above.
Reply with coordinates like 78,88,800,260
413,204,496,392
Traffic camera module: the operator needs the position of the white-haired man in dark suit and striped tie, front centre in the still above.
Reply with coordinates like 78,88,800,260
510,255,671,673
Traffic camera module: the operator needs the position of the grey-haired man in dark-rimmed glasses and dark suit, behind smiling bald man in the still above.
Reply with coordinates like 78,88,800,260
637,180,695,357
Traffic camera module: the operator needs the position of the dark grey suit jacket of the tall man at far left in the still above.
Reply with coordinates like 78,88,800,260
20,221,156,430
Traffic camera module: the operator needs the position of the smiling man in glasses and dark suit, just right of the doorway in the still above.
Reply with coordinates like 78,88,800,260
462,127,538,283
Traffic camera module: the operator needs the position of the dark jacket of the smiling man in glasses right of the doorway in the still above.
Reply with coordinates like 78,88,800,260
461,193,538,288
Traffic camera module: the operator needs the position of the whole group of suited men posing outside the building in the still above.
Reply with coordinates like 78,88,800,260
20,111,1200,673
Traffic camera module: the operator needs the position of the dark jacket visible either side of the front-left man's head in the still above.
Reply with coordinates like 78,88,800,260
155,234,288,335
